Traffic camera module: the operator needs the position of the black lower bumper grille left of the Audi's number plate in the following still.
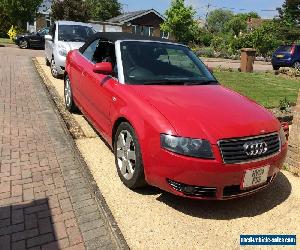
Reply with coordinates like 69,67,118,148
167,179,217,198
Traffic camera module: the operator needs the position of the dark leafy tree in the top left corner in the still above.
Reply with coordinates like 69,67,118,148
0,0,42,28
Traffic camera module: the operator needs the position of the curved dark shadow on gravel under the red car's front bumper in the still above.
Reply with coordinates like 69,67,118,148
157,173,292,220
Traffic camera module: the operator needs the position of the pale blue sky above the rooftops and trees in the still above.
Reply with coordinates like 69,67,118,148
120,0,284,18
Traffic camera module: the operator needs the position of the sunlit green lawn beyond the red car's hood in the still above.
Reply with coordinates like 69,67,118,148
214,71,300,108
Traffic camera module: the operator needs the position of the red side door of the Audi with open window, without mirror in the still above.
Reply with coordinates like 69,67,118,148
80,41,116,139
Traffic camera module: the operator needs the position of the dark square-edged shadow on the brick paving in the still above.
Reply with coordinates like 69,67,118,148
0,199,60,250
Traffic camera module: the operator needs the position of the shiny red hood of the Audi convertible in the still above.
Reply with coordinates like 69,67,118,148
131,85,280,144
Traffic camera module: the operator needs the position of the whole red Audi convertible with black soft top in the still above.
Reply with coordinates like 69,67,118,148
64,33,287,199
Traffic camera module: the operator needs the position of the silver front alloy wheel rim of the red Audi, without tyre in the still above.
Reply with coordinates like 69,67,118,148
117,130,136,180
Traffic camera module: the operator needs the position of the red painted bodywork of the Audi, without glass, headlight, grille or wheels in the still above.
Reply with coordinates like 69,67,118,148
66,47,287,199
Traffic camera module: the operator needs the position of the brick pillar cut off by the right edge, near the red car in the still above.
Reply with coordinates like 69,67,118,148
287,92,300,175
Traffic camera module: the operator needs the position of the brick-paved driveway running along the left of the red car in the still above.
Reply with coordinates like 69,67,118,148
0,48,120,250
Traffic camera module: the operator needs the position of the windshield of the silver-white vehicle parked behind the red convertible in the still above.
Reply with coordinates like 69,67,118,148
58,25,95,42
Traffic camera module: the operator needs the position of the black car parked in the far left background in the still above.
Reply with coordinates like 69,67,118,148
15,27,49,49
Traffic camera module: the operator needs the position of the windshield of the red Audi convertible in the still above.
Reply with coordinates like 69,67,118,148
121,41,218,85
